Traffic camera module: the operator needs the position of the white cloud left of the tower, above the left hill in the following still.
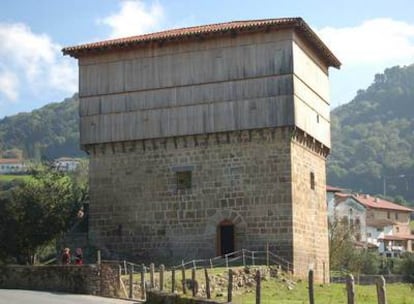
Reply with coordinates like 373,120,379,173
0,23,77,102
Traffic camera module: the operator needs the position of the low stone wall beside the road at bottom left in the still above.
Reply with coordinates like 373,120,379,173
0,264,120,297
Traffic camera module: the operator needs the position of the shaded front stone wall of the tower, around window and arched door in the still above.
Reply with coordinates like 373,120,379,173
87,128,293,263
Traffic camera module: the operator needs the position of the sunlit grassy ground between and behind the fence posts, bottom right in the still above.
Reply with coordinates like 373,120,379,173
123,268,414,304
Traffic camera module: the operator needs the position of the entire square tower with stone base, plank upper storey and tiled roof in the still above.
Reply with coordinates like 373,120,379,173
63,18,340,280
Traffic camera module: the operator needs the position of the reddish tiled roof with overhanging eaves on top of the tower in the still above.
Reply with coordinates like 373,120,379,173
62,18,341,68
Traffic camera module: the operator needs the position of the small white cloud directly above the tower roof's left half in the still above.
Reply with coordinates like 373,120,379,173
98,0,164,38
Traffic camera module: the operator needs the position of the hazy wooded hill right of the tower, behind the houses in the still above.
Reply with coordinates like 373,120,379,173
328,64,414,201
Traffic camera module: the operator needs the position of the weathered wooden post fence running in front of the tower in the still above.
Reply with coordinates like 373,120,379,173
98,250,387,304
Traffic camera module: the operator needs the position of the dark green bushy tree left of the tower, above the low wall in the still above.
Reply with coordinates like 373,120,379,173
0,167,83,264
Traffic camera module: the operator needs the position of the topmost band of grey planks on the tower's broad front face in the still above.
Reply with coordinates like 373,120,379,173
79,41,292,97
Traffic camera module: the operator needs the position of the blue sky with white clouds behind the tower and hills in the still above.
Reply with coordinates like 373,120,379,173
0,0,414,119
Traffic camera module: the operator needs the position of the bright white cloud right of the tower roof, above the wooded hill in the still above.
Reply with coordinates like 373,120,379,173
318,18,414,67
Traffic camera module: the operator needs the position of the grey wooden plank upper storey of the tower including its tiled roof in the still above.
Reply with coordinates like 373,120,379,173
63,18,340,147
